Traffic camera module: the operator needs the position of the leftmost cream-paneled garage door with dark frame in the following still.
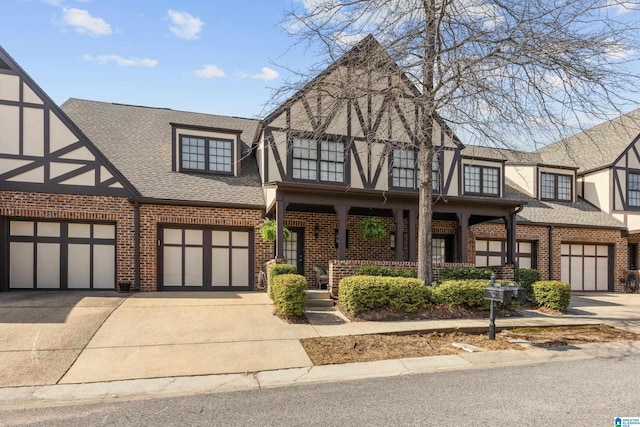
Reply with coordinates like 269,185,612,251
9,220,116,289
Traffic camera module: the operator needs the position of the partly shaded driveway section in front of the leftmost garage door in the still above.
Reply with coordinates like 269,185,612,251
0,292,125,387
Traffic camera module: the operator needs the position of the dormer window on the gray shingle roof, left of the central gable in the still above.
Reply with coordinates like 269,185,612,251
180,136,233,173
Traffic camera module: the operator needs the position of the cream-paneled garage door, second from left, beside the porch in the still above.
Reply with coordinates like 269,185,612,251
158,226,253,291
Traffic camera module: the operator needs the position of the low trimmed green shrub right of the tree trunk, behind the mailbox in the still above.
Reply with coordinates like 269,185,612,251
431,280,491,310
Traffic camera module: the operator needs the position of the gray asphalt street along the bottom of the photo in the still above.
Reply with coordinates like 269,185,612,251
0,354,640,427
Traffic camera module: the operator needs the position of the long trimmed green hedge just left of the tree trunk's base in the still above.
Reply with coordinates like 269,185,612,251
338,276,431,315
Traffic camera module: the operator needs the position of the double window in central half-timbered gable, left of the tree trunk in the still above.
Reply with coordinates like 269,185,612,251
291,138,345,182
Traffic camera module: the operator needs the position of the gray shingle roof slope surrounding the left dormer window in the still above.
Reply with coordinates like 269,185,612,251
62,98,264,208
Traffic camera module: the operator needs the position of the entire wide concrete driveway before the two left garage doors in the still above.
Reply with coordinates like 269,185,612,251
0,292,317,387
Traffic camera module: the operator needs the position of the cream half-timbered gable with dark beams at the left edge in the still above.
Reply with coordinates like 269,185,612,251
0,46,137,197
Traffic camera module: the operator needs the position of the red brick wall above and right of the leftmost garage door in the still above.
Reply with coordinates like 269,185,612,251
0,191,135,283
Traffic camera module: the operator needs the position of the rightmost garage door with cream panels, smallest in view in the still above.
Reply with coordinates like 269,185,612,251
561,244,609,291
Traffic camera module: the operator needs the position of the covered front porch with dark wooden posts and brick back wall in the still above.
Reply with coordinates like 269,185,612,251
267,183,522,288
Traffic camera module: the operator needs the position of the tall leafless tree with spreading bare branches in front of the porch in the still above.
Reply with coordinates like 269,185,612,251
276,0,640,283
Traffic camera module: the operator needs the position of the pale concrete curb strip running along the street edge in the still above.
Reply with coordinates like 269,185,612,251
0,341,640,410
